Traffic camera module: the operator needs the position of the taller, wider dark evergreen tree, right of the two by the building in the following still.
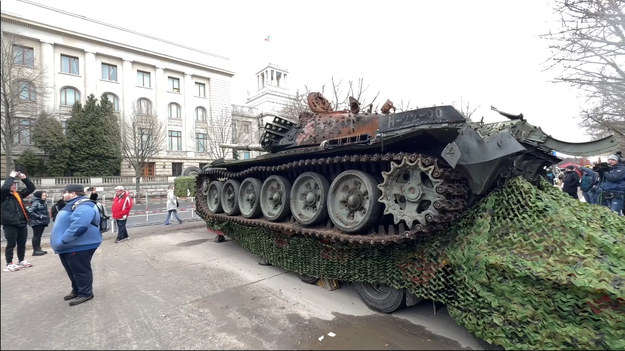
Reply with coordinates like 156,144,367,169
67,94,121,176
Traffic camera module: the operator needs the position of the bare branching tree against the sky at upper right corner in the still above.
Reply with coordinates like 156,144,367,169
543,0,625,148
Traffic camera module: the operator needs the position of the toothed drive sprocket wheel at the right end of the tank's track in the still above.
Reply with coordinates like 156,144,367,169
378,158,445,228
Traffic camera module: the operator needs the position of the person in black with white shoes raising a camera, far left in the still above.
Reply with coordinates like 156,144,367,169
0,170,35,272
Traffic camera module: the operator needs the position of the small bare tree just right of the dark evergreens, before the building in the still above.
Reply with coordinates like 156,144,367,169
121,106,165,199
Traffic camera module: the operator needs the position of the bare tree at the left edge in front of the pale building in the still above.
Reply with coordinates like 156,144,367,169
0,32,47,175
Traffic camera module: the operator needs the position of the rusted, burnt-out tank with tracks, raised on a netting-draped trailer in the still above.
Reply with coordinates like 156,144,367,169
197,93,616,245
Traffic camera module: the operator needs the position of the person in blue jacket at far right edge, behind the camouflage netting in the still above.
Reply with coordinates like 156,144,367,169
599,155,625,214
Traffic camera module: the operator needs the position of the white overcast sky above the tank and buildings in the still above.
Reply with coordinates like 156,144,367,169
35,0,590,142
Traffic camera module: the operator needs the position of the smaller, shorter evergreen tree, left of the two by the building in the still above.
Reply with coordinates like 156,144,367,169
32,112,70,177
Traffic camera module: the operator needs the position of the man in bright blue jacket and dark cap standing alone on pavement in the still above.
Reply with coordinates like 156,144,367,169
50,184,102,306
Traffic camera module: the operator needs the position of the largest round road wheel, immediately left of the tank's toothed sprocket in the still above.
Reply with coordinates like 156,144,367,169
328,170,380,233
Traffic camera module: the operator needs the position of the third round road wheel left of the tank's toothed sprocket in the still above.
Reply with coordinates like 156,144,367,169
260,175,291,222
